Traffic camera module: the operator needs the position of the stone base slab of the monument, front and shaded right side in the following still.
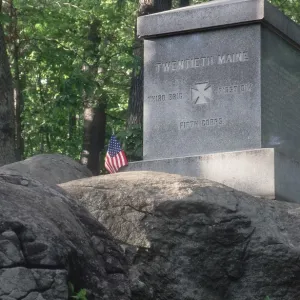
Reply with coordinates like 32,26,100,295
123,148,300,203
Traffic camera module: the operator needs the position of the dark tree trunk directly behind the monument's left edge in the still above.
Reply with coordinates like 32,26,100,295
127,0,172,127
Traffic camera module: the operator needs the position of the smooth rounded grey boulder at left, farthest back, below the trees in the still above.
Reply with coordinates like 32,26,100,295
0,154,92,186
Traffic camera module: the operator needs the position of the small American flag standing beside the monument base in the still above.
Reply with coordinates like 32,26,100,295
105,135,128,173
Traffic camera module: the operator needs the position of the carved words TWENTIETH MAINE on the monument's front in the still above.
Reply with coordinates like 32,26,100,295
155,51,249,73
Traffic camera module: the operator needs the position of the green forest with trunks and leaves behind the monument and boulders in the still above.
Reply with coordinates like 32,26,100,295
0,0,300,175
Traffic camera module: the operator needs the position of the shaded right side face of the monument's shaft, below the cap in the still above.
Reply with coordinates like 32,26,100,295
261,27,300,162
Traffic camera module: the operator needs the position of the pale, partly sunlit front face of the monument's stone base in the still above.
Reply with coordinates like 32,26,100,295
123,149,276,201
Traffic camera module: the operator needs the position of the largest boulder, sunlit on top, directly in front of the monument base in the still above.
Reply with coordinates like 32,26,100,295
60,172,300,300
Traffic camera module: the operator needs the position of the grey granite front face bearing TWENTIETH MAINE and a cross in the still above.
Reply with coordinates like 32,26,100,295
143,25,261,160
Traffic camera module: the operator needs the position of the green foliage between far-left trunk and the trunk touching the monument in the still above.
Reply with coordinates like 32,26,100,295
7,0,136,159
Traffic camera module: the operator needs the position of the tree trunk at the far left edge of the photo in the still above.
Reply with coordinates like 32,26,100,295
0,19,16,166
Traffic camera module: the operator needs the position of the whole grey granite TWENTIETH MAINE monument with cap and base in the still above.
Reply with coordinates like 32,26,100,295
127,0,300,202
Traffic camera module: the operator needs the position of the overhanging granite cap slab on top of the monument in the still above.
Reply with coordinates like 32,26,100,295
137,0,300,44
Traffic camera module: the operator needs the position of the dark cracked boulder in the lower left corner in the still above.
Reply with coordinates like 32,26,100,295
0,174,130,300
